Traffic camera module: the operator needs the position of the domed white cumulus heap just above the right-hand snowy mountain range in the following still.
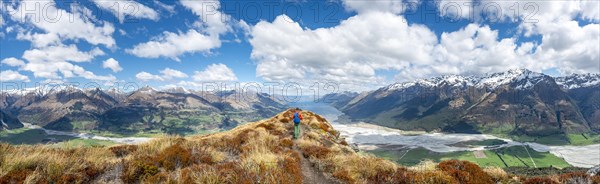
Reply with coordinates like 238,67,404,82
396,24,546,80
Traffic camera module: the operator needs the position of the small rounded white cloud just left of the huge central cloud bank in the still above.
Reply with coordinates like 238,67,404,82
193,63,237,82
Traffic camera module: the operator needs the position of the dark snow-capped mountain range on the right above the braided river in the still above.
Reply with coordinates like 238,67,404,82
334,70,600,136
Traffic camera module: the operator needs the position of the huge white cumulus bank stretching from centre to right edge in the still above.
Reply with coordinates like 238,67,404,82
250,0,600,89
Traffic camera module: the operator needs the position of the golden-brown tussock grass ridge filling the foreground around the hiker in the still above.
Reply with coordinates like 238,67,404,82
0,108,599,184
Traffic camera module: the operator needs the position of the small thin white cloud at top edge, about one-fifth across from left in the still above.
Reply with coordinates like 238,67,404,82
93,0,159,23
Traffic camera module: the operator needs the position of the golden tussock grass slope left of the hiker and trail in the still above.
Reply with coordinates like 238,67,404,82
0,109,302,183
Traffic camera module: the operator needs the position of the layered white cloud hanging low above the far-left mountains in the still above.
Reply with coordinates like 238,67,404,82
21,45,116,81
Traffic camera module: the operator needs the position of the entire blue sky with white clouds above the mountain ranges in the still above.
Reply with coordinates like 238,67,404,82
0,0,600,91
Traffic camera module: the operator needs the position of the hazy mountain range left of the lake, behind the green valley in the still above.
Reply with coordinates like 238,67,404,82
0,87,285,134
